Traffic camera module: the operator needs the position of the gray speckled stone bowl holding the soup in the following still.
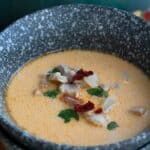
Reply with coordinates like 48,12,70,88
0,5,150,150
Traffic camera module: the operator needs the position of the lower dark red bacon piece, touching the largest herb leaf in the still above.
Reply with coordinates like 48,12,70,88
74,101,94,113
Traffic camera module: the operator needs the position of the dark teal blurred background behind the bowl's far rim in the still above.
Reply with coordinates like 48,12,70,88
0,0,150,31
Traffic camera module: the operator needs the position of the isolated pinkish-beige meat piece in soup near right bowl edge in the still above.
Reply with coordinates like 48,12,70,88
130,107,147,116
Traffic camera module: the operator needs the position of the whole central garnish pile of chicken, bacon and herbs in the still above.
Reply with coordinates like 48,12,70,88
32,65,119,128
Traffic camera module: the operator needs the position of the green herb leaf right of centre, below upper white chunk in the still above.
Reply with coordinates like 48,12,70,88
87,87,108,97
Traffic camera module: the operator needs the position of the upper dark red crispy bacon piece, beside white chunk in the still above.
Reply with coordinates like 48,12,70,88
72,69,93,82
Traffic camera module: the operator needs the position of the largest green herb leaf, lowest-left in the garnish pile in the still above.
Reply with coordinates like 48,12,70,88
58,108,79,123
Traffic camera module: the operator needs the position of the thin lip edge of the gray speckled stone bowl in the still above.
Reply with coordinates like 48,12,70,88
0,4,150,149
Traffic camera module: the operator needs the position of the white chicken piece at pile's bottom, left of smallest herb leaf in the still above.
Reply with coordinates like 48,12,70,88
84,111,110,127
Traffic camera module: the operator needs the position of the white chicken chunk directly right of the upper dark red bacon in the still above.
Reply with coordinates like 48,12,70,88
83,74,99,88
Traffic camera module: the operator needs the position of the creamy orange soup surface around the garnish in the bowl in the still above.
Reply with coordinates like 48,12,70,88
6,50,150,146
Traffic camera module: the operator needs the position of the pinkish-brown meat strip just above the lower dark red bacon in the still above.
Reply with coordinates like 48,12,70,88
61,93,83,106
